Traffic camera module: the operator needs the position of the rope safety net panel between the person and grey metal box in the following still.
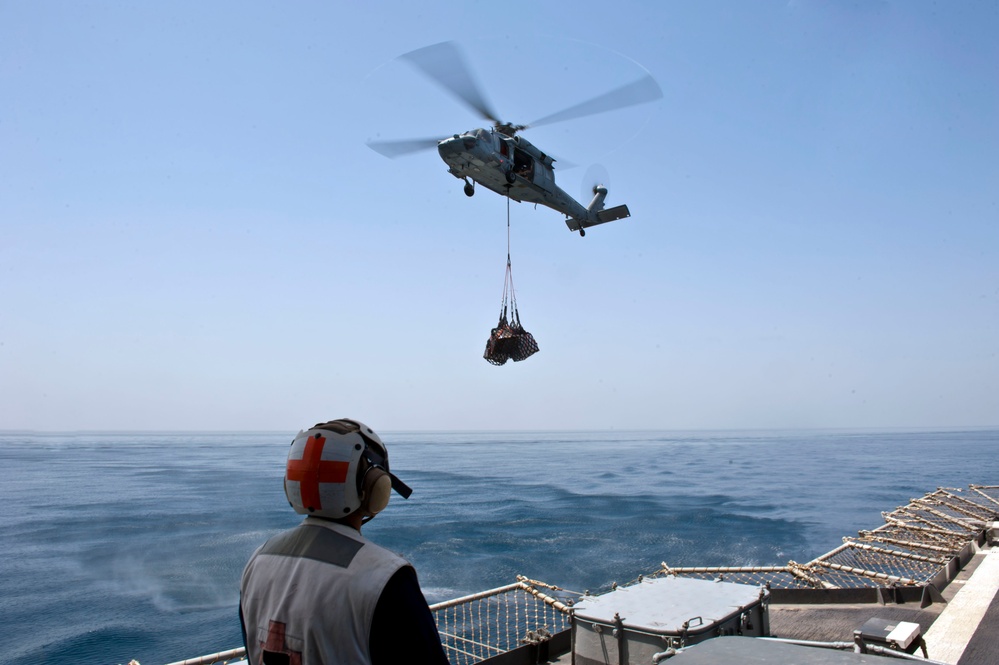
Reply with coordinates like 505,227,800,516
430,575,578,665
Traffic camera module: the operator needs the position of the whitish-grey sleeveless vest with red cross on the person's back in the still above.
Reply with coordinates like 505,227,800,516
240,517,409,665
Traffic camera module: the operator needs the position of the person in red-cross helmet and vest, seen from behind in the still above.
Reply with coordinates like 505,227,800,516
239,419,448,665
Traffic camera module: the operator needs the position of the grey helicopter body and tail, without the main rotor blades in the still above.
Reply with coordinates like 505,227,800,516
437,128,630,232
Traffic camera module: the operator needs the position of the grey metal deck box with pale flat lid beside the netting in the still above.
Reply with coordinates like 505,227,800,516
572,577,770,665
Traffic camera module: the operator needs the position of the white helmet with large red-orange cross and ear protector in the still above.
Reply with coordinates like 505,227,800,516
284,418,413,519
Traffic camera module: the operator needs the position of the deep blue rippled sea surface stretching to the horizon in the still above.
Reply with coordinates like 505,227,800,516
0,429,999,665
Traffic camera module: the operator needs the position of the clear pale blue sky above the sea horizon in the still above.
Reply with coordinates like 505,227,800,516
0,0,999,431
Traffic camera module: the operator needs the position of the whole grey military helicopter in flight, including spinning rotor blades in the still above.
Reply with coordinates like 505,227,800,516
367,42,662,236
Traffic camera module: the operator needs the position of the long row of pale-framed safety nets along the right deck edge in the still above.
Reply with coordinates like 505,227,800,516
639,485,999,589
